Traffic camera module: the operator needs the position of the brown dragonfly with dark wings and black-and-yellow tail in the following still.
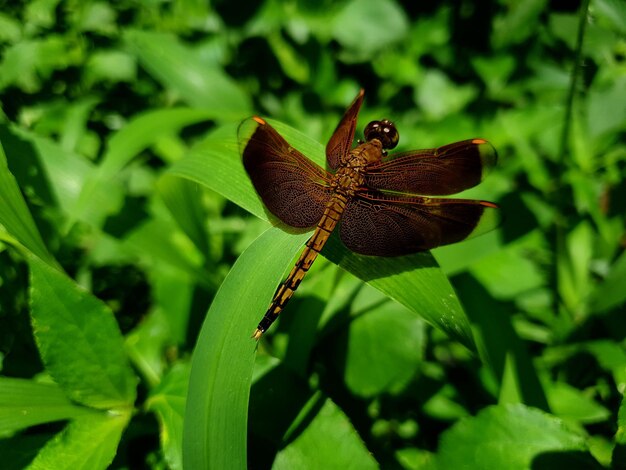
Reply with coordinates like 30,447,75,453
239,90,499,340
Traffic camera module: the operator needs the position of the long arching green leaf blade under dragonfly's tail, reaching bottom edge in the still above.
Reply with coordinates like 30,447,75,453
183,228,308,469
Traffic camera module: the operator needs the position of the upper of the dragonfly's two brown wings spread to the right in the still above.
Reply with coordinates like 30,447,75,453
365,139,498,196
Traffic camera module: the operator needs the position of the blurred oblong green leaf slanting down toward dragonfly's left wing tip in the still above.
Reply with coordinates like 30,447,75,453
125,31,251,120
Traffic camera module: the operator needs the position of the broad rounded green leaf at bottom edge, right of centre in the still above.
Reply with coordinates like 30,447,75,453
437,405,593,470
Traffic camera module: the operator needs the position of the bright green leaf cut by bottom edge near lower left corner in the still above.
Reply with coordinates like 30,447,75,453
28,411,130,470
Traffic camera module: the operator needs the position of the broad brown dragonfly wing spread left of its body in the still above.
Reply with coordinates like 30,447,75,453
239,116,332,227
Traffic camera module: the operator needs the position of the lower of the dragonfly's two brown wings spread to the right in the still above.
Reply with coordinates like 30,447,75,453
339,192,499,256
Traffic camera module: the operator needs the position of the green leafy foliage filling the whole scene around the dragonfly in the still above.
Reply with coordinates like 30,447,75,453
0,0,626,469
